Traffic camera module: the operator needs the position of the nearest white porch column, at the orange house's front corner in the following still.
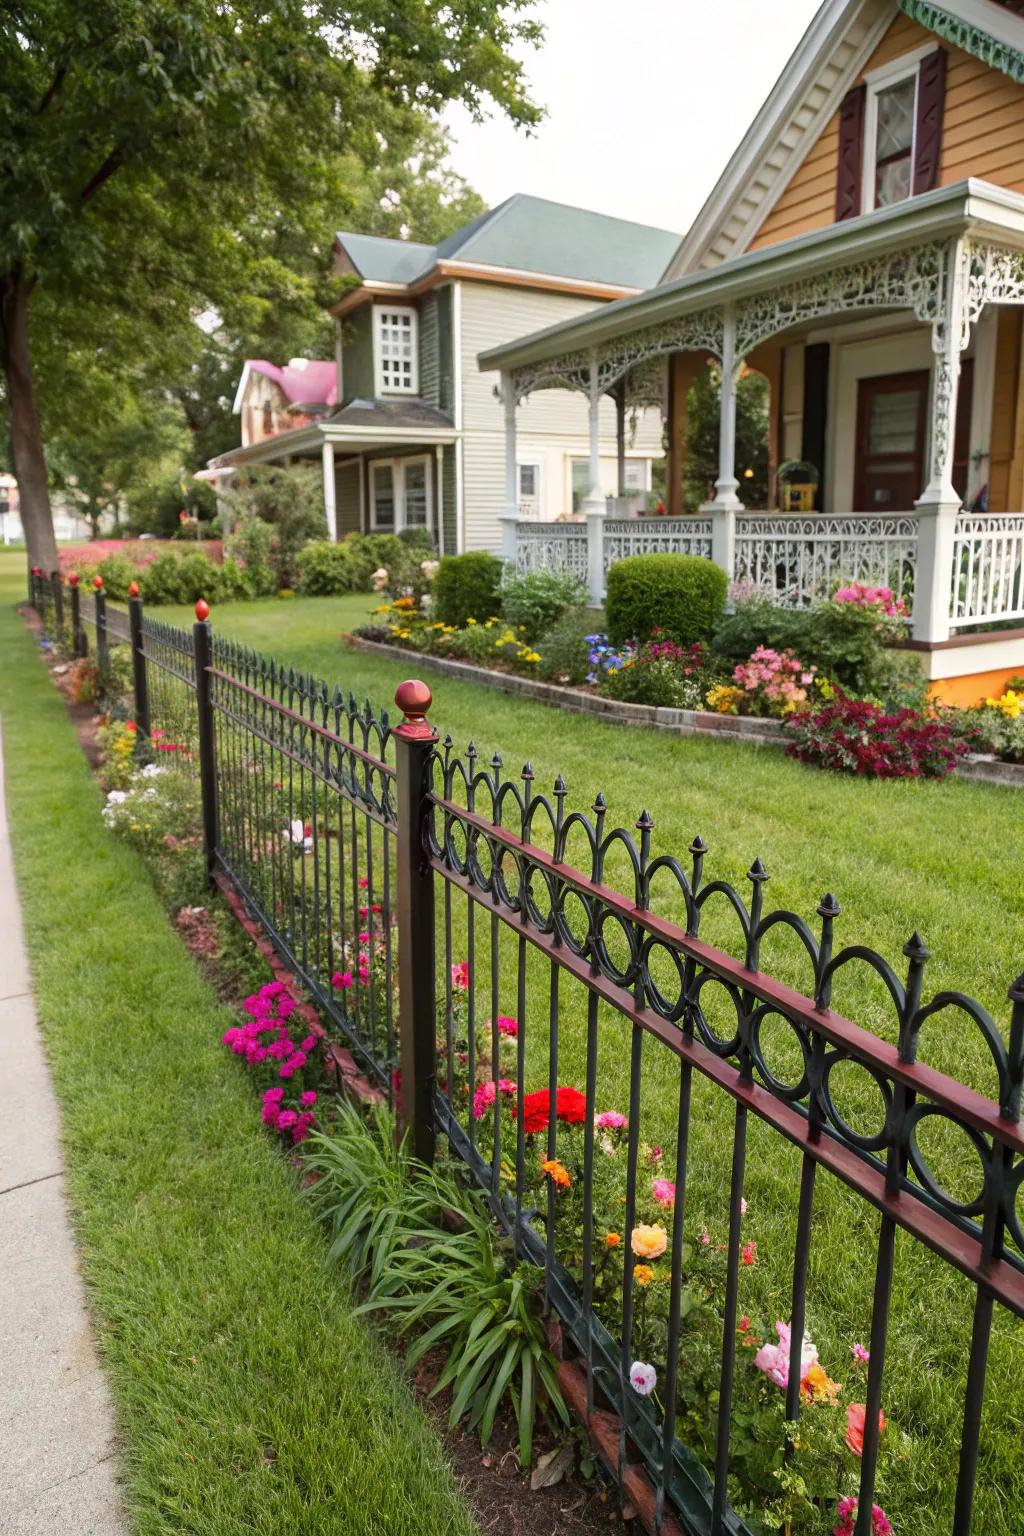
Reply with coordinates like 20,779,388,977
913,240,970,641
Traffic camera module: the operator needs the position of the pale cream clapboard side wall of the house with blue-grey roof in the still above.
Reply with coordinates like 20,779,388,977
462,283,662,551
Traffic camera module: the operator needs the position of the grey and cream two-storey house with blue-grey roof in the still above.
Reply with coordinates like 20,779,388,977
210,195,679,553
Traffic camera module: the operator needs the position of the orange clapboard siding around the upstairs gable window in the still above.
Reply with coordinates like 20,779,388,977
749,15,1024,250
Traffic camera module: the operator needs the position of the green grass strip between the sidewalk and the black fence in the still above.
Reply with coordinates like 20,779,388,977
0,556,476,1536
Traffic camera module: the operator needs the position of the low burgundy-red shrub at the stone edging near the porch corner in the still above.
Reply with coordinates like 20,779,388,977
786,694,967,779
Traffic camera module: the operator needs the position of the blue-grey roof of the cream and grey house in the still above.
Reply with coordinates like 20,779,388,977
338,192,679,289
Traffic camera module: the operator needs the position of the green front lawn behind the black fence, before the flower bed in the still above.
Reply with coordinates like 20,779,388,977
154,580,1024,1536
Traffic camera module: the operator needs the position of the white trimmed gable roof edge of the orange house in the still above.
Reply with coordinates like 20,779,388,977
663,0,1024,281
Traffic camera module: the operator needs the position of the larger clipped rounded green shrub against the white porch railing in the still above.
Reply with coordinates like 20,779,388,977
605,554,726,645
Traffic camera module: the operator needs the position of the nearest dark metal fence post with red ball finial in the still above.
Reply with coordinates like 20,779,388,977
393,680,438,1164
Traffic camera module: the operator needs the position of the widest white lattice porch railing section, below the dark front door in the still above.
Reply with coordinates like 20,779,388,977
732,513,918,608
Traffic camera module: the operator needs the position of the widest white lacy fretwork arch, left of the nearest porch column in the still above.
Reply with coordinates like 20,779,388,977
735,241,947,358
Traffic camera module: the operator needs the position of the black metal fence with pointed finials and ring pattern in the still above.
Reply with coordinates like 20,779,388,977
26,571,1024,1536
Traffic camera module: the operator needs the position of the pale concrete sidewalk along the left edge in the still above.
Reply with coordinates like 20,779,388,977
0,724,127,1536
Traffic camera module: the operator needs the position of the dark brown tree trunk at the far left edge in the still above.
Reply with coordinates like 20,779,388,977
0,269,57,571
